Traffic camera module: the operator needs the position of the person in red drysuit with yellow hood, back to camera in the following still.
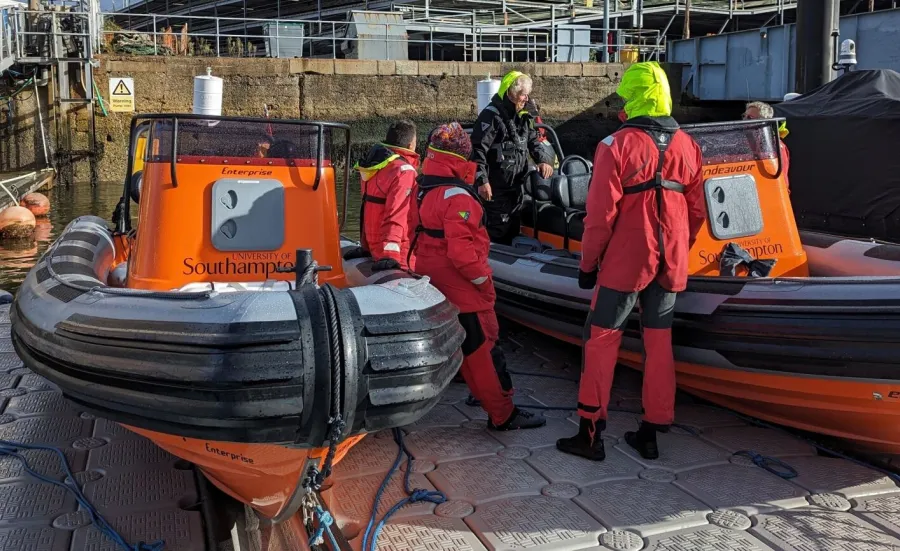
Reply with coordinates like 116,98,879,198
556,62,705,461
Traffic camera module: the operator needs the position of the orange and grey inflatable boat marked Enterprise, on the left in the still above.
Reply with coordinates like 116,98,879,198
11,115,465,521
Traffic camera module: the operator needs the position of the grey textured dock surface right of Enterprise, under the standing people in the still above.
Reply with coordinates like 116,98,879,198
326,331,900,551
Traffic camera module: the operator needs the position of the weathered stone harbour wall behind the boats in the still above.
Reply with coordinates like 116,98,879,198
6,56,736,181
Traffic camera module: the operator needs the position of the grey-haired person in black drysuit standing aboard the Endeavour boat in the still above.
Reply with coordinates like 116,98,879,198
471,71,553,245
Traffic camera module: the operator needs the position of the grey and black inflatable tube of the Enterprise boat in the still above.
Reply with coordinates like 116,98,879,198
10,217,465,447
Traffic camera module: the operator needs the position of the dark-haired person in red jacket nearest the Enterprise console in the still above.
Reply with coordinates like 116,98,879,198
344,121,419,272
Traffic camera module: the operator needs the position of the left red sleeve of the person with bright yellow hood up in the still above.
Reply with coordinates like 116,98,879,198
581,136,622,272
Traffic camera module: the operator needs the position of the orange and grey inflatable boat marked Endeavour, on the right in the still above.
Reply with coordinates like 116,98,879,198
491,121,900,453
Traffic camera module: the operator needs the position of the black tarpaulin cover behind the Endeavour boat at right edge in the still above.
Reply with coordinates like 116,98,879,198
775,70,900,241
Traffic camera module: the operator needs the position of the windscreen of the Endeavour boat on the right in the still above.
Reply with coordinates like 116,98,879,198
682,120,778,165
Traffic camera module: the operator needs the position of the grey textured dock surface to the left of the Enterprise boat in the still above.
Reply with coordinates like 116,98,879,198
0,307,207,551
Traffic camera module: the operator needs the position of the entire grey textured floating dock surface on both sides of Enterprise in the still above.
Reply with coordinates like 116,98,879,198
0,298,900,551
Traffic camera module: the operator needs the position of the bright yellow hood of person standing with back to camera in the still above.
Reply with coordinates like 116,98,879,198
616,61,672,119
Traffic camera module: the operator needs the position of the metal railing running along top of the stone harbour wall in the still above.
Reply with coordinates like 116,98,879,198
10,10,665,62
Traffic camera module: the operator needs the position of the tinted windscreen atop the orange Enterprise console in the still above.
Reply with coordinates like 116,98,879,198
148,118,332,162
